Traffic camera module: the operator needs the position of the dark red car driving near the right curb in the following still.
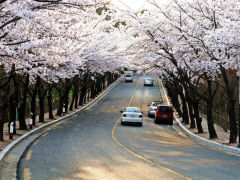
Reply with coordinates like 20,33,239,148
154,104,173,125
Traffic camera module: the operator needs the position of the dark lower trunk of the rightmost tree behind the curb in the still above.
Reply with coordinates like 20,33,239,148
228,99,237,143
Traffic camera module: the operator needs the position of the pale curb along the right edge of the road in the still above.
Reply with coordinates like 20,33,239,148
158,79,240,155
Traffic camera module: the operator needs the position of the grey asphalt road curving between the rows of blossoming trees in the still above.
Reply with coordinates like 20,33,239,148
18,76,240,180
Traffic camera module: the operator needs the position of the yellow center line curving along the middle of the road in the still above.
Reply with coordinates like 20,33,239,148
112,77,192,180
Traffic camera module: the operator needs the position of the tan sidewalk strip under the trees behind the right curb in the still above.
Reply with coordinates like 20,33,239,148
177,115,238,147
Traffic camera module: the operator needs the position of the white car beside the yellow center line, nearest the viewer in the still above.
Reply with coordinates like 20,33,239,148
120,107,143,126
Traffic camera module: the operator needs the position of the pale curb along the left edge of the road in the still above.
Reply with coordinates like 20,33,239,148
0,76,122,162
